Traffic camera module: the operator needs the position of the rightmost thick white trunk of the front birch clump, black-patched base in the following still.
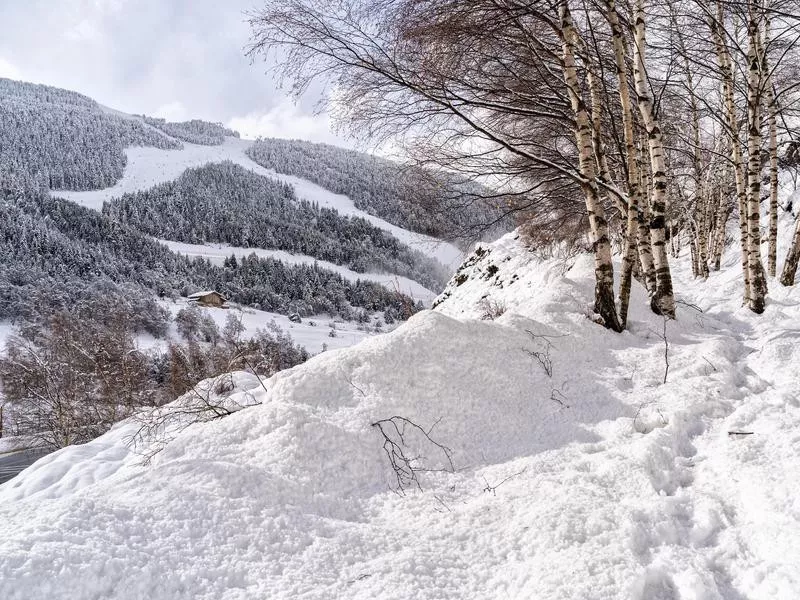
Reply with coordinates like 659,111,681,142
633,0,675,319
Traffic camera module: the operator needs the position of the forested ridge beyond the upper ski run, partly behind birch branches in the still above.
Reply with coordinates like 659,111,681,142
247,138,513,240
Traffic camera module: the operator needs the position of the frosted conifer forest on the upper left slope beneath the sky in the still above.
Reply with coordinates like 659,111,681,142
0,78,181,190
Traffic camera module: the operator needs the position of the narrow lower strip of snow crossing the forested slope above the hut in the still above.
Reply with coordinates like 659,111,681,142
158,239,436,306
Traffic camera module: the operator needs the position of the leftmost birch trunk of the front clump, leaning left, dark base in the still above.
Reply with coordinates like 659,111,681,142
559,0,622,331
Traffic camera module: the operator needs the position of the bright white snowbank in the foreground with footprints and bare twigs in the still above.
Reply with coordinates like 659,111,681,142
0,200,800,600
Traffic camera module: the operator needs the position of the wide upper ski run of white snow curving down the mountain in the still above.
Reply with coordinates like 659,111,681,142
53,135,463,268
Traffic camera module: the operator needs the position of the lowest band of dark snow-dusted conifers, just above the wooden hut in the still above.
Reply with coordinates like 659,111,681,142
0,185,416,319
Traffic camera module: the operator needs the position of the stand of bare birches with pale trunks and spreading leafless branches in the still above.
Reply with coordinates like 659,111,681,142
249,0,800,330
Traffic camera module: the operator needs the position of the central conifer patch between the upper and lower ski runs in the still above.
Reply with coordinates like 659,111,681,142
103,162,448,289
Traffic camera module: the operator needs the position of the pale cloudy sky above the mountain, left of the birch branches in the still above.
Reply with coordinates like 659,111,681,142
0,0,349,145
